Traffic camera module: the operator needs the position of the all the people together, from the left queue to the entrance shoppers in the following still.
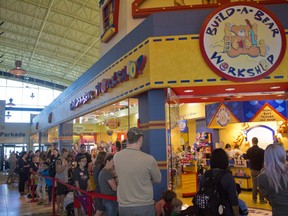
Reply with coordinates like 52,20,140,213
3,132,288,216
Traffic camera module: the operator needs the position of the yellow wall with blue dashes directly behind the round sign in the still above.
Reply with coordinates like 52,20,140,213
149,35,288,88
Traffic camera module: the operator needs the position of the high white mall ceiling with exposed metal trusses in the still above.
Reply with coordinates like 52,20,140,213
0,0,100,86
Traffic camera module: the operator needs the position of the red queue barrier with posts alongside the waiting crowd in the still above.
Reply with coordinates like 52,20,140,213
29,172,117,216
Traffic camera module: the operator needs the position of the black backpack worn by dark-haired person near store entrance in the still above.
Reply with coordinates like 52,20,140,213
193,170,227,216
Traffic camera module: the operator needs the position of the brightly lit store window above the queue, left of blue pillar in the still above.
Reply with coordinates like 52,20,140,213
73,98,138,149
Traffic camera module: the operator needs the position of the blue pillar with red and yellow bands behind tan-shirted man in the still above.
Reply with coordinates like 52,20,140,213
138,89,168,201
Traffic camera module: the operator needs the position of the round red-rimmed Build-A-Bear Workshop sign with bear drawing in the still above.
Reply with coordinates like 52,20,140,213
200,2,286,82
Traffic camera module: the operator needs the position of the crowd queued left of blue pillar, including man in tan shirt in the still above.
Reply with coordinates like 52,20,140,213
3,127,161,216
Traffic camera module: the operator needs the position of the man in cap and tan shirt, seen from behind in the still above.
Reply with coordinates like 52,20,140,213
114,127,161,216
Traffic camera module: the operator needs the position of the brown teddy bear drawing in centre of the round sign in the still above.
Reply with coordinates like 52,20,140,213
224,19,267,58
